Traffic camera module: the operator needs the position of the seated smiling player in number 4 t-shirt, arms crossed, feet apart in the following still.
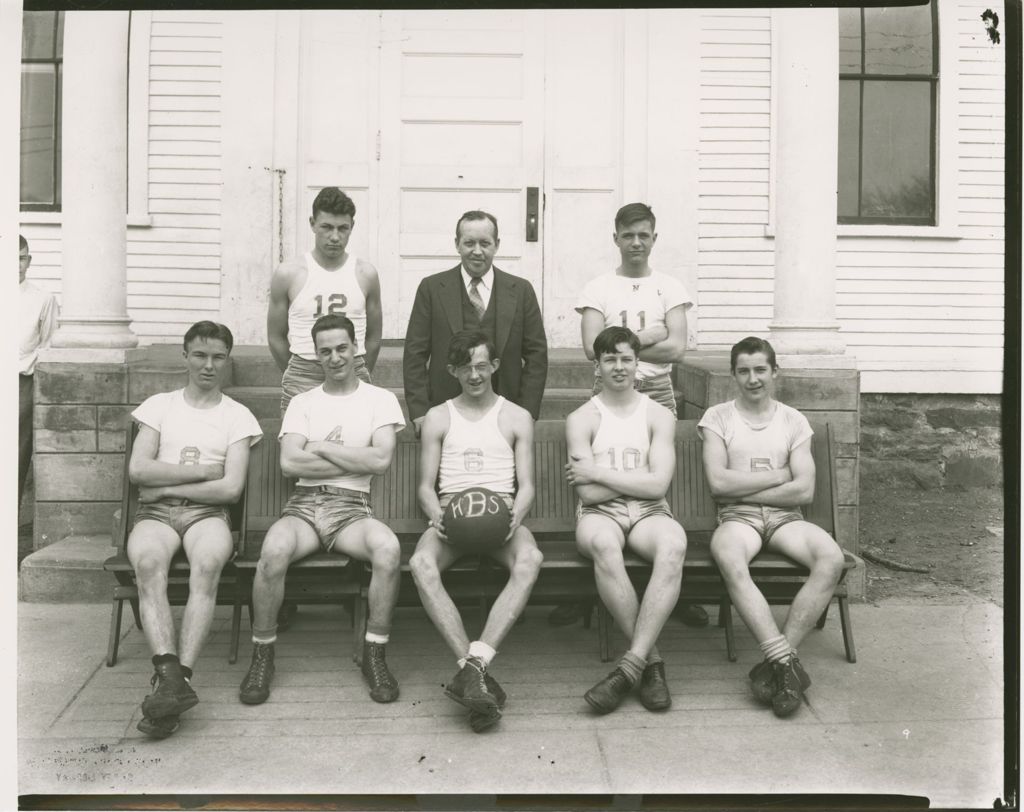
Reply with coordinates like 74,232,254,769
239,315,406,704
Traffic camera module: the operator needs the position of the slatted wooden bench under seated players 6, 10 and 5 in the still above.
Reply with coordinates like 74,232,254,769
344,420,856,663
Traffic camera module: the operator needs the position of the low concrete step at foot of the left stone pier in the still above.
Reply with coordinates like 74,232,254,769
17,536,116,603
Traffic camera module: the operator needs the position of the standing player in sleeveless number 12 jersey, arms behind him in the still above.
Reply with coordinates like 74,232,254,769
266,186,382,416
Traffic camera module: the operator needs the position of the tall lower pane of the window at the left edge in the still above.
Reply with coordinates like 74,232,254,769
22,65,56,203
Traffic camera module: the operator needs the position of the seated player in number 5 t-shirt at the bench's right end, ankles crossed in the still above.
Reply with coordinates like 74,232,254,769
697,336,844,717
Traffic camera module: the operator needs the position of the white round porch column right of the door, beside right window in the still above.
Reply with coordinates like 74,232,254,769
769,8,845,368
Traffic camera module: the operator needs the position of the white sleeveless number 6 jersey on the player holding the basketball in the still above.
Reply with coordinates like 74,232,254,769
437,396,515,494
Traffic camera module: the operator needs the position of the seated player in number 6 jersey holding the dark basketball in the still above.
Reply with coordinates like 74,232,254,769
410,330,543,732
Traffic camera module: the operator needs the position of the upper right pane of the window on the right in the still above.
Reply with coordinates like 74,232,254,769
864,5,932,74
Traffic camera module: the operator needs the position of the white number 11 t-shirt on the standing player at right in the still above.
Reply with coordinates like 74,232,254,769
575,270,693,379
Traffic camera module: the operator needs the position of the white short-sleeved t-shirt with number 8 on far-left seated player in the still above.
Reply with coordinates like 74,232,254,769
131,389,263,465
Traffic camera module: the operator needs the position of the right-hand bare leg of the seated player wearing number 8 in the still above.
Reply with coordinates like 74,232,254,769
178,518,233,668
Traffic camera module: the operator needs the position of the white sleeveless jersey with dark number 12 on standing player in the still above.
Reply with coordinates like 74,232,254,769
288,252,367,360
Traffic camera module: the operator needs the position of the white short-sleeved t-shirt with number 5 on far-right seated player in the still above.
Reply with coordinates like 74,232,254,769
697,400,814,487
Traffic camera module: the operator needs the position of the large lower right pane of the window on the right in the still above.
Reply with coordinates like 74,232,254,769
860,81,933,218
